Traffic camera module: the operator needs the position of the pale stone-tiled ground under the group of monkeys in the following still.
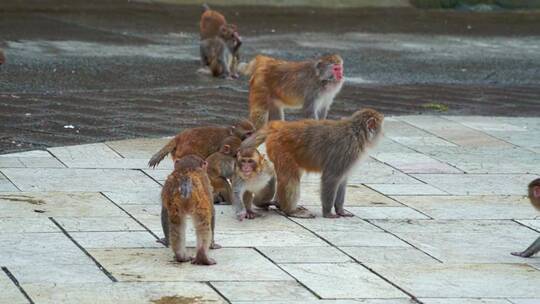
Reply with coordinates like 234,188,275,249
0,116,540,304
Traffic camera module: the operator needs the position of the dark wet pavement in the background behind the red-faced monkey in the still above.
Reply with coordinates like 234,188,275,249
0,1,540,152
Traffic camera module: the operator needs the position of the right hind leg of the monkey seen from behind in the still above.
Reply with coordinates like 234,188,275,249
191,213,216,265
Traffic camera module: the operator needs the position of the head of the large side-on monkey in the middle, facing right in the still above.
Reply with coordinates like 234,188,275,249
351,108,384,145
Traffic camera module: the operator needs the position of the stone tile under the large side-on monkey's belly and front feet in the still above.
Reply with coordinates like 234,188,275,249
299,183,400,206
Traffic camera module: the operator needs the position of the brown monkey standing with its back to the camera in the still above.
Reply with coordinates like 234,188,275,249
161,155,216,265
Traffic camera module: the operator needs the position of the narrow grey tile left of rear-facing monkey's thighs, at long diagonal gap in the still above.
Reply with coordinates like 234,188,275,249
54,215,144,232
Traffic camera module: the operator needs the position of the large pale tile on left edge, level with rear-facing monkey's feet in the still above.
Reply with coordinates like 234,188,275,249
0,233,91,267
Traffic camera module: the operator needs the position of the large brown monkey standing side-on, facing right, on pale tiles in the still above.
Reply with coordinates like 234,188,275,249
240,109,384,218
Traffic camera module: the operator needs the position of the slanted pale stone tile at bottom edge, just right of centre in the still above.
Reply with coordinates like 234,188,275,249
281,263,406,299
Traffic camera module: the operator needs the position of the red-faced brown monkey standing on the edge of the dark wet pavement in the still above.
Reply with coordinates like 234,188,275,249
247,54,344,130
